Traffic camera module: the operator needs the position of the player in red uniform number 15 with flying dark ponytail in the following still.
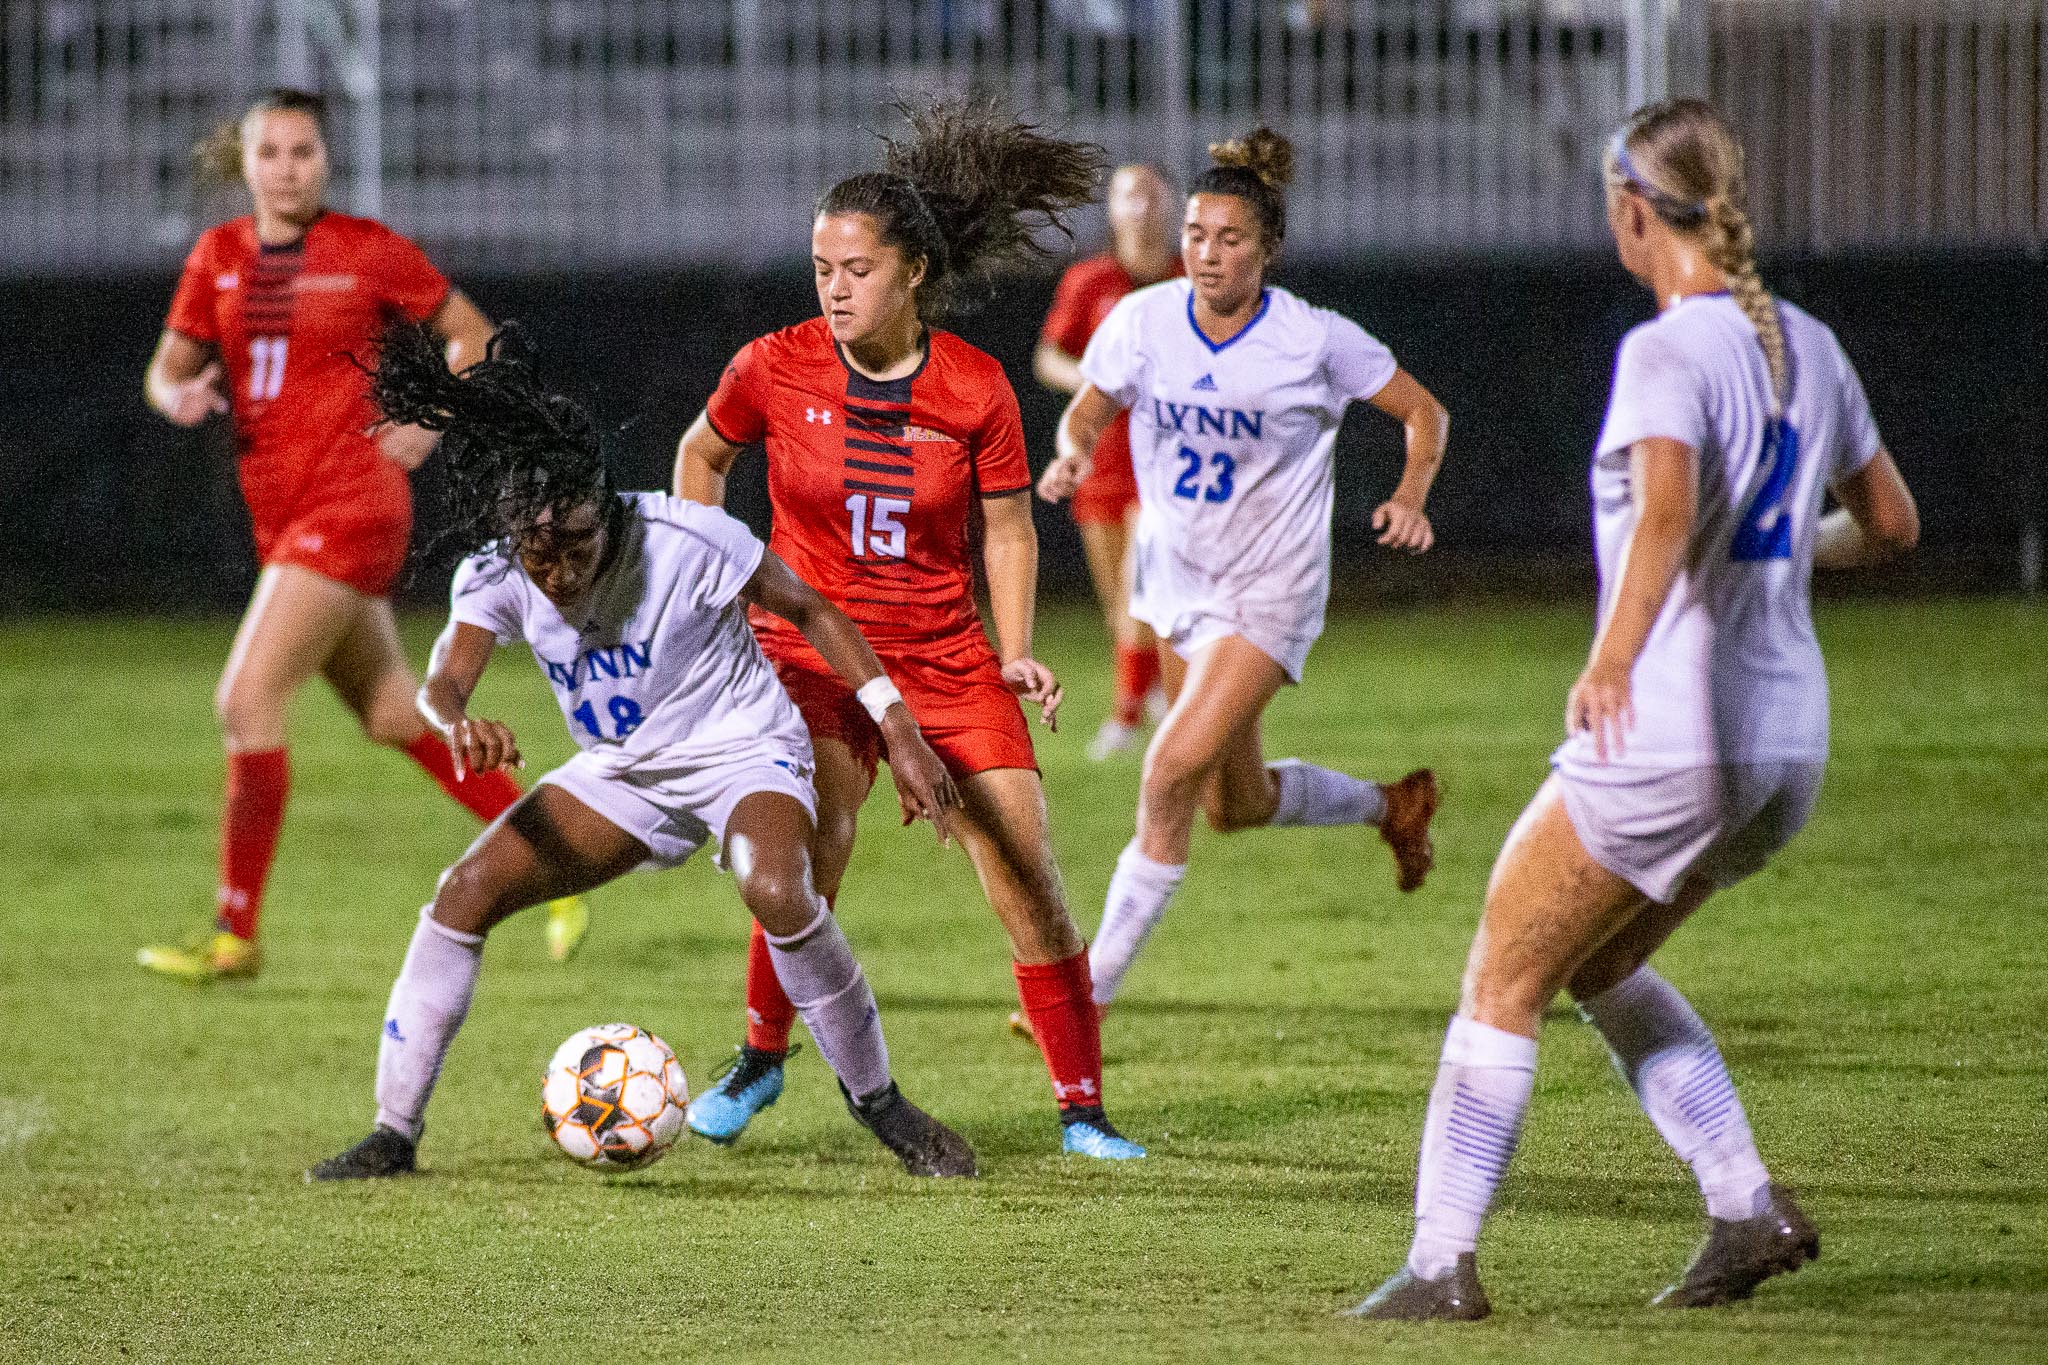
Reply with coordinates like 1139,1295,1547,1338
676,104,1145,1160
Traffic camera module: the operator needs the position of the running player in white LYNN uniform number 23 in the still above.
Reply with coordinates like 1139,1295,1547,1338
1038,127,1450,1007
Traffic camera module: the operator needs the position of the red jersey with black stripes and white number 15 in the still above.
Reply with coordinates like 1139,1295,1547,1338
705,317,1030,645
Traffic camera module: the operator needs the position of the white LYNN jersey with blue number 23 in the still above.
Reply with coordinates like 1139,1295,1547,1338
1081,280,1397,641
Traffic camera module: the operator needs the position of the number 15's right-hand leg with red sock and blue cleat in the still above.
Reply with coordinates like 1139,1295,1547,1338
956,767,1145,1160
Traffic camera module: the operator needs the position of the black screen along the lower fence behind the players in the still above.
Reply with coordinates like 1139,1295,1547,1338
0,256,2048,612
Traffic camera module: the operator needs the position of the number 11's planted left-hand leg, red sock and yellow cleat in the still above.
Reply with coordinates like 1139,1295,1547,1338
137,565,367,980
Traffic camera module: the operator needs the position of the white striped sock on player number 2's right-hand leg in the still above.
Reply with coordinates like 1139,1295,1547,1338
1579,966,1772,1220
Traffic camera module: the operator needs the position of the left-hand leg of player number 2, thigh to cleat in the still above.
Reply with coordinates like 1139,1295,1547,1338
1352,778,1647,1318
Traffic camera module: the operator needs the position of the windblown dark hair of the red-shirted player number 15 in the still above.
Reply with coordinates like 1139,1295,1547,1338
817,100,1108,321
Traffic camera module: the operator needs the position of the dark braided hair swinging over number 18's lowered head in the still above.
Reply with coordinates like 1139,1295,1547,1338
365,323,625,561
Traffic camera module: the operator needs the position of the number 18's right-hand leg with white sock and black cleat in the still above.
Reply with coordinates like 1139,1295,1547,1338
723,790,975,1177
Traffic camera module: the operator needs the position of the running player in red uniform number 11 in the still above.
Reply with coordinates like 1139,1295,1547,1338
137,90,588,980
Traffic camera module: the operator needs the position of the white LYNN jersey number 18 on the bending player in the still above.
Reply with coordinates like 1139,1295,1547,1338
449,493,809,772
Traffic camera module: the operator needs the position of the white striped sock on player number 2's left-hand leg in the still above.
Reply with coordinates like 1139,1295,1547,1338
1409,1015,1536,1279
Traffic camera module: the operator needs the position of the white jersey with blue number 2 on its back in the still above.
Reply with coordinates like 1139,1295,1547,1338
1559,295,1878,767
